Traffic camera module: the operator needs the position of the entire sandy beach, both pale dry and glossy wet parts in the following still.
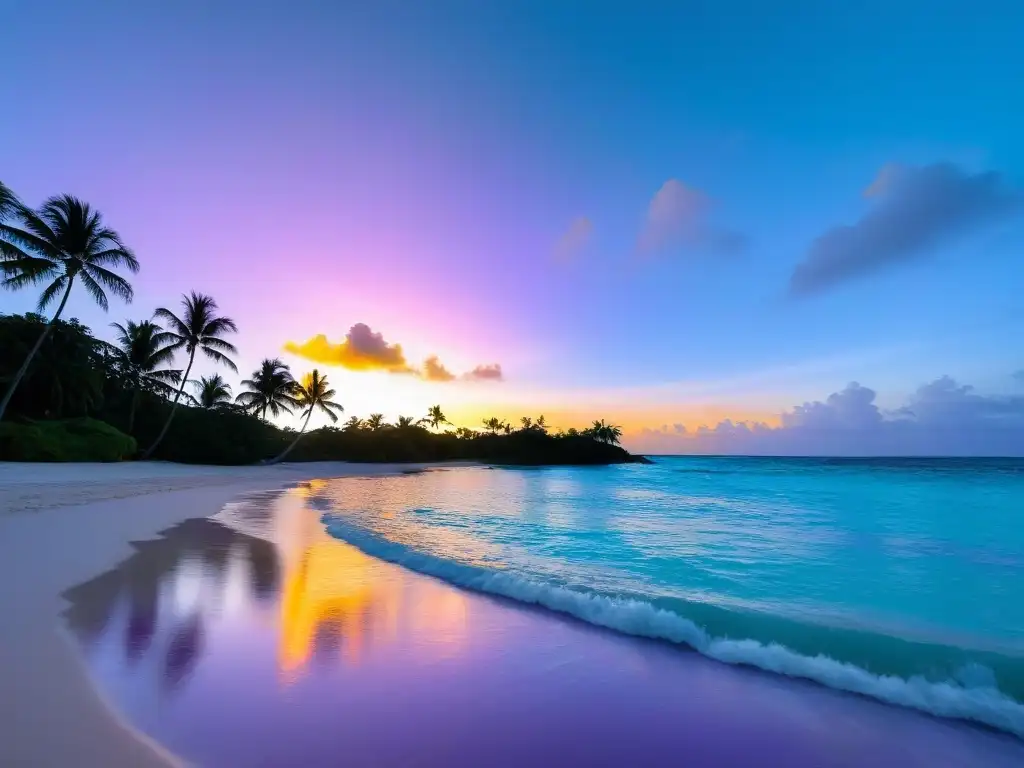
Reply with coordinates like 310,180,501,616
0,464,1024,768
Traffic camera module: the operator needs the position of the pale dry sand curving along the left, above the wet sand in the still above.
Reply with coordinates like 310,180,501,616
0,462,436,768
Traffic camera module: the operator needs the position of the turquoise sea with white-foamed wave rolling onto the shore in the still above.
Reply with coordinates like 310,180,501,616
311,458,1024,735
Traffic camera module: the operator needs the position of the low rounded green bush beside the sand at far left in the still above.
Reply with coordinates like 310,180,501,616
0,418,137,462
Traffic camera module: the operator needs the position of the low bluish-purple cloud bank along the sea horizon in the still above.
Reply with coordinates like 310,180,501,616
639,376,1024,456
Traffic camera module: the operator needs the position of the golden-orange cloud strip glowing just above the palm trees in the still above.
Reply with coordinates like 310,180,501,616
285,323,502,382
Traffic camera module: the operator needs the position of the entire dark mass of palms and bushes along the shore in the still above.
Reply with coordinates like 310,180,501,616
0,183,634,465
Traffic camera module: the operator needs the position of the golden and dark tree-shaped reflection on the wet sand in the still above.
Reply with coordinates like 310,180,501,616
65,483,467,691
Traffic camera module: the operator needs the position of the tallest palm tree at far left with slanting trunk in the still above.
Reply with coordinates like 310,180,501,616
0,187,138,419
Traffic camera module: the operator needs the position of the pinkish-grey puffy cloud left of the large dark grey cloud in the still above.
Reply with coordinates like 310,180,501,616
637,178,746,254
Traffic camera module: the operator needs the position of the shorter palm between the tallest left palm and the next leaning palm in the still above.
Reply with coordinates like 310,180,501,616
110,321,181,434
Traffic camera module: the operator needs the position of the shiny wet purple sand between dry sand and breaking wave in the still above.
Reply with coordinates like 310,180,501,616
63,479,1024,768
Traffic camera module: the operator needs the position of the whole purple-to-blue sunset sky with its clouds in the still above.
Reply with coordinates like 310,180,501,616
0,0,1024,454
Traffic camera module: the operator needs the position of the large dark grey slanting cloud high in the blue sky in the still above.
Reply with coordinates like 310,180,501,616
790,163,1024,296
